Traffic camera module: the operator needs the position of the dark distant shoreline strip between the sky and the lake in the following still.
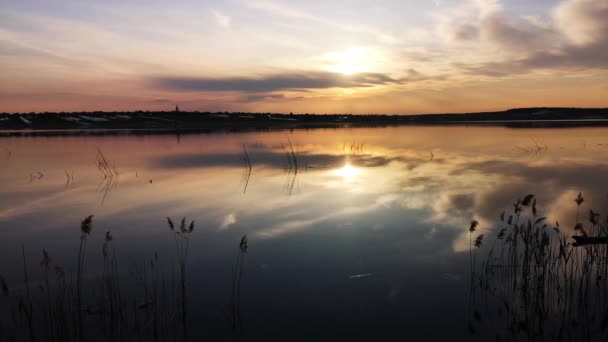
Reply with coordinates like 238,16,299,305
0,108,608,136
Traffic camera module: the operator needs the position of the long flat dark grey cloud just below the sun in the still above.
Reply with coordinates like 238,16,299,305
151,71,403,92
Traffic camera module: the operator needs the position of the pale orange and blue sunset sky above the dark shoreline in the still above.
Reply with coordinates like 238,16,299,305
0,0,608,114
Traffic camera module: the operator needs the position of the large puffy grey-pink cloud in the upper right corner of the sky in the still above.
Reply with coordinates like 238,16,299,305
456,0,608,76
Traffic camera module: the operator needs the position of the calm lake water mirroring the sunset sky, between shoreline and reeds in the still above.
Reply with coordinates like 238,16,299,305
0,127,608,341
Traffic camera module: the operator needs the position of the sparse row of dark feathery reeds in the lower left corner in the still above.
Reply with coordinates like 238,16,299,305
0,215,205,342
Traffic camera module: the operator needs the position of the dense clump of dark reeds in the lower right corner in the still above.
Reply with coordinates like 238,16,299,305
470,194,608,341
